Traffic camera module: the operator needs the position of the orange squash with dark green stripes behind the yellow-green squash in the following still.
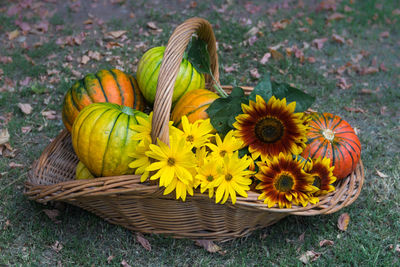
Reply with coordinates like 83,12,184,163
62,69,145,131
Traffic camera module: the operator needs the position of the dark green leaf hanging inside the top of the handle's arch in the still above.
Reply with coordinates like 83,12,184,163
188,37,211,75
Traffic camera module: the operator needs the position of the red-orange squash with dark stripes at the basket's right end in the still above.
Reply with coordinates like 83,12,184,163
302,113,361,179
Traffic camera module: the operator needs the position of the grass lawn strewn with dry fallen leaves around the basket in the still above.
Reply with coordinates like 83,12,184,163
0,0,400,266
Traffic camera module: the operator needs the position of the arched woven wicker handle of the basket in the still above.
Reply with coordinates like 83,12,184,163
151,18,219,144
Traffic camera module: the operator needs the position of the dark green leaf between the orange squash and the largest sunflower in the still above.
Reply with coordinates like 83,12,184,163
206,87,249,136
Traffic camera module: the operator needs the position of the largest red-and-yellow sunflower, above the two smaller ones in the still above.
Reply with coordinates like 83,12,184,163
233,95,308,160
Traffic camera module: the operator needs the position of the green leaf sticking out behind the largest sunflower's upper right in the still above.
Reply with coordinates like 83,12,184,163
272,82,315,112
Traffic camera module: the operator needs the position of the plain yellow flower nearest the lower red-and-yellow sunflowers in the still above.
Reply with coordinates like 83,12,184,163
212,151,253,204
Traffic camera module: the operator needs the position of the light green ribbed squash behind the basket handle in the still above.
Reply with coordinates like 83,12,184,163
136,46,205,104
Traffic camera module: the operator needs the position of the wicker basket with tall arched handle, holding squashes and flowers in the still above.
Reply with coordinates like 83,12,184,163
25,18,364,241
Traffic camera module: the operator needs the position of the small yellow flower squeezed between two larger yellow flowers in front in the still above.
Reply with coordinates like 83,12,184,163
195,157,222,198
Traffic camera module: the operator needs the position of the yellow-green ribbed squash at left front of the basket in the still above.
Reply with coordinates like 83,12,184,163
71,103,148,177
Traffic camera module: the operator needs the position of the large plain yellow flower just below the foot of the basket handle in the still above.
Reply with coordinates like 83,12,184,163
145,134,196,187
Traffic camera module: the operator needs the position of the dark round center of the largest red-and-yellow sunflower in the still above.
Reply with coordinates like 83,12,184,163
254,118,284,143
